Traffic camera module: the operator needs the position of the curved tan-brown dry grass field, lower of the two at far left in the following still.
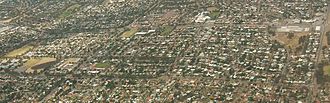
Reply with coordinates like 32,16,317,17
23,58,56,73
